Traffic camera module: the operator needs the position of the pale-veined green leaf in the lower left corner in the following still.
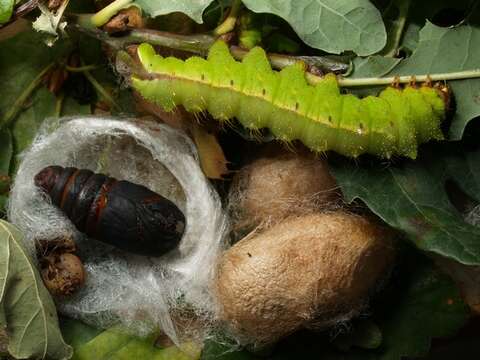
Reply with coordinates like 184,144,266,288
0,220,72,359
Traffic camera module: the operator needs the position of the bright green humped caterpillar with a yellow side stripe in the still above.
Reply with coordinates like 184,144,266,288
131,41,448,158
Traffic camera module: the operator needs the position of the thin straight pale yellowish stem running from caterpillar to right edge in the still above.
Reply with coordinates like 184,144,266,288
330,68,480,87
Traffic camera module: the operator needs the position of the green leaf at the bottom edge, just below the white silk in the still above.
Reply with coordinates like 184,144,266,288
73,329,200,360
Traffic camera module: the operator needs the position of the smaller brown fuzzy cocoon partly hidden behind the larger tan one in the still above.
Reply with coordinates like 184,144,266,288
229,146,340,230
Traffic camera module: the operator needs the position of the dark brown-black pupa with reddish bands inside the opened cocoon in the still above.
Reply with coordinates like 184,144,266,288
34,166,185,256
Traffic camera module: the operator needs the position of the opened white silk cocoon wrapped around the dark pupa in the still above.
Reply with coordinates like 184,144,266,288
8,117,227,344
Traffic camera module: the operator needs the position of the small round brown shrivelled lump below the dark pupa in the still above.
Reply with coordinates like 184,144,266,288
41,253,86,296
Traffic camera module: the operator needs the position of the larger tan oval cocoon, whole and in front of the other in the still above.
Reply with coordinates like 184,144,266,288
214,211,394,346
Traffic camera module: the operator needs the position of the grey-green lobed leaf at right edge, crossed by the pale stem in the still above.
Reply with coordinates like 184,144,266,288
389,22,480,140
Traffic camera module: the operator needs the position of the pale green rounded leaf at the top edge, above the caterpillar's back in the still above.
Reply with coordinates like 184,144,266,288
243,0,387,56
